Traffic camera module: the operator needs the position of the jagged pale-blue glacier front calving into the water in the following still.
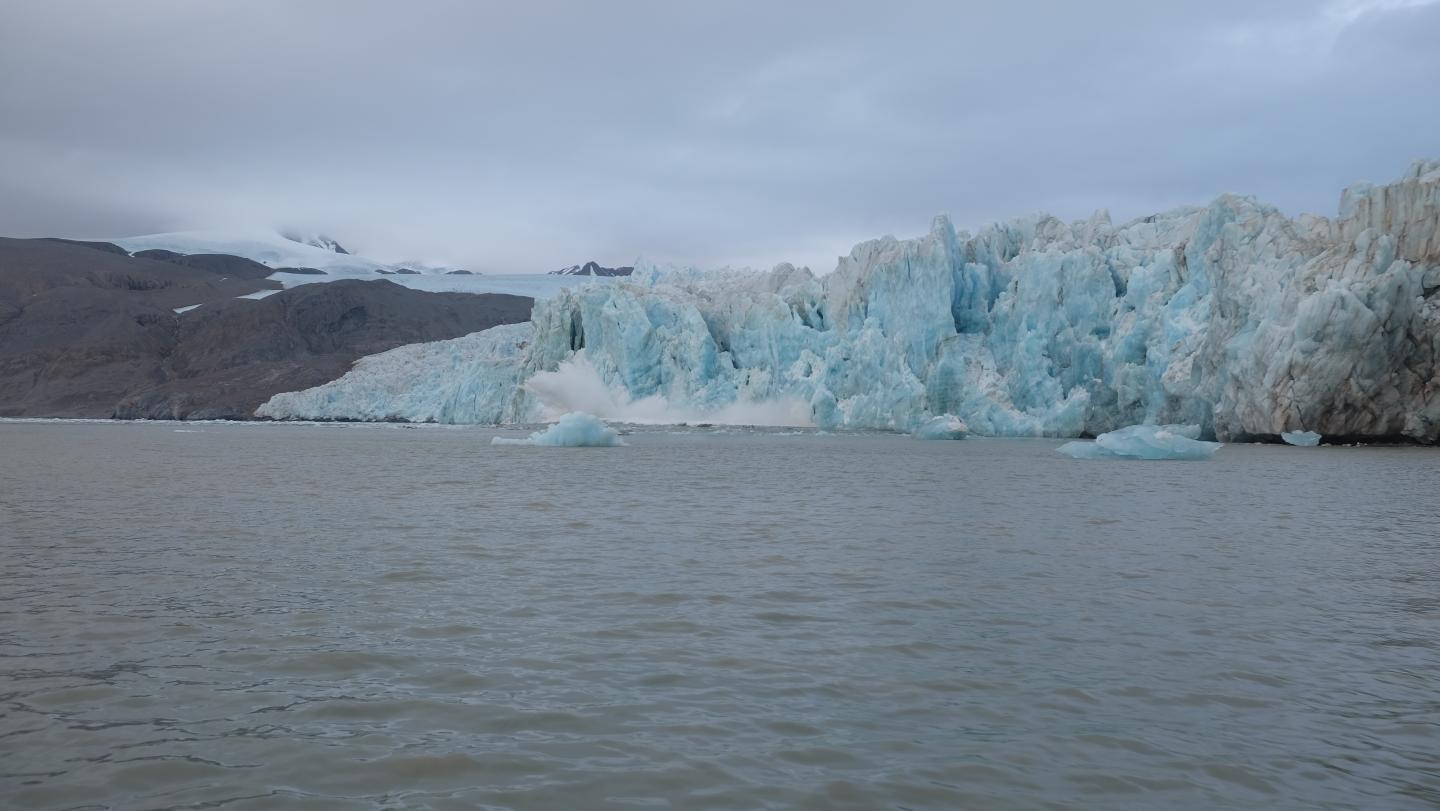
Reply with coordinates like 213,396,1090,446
259,161,1440,442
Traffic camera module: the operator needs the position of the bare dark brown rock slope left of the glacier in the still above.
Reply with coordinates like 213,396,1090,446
0,239,533,419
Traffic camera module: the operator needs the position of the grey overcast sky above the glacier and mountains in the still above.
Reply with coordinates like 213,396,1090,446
0,0,1440,272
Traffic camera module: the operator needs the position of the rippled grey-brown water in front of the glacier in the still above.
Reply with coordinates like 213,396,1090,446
0,424,1440,810
